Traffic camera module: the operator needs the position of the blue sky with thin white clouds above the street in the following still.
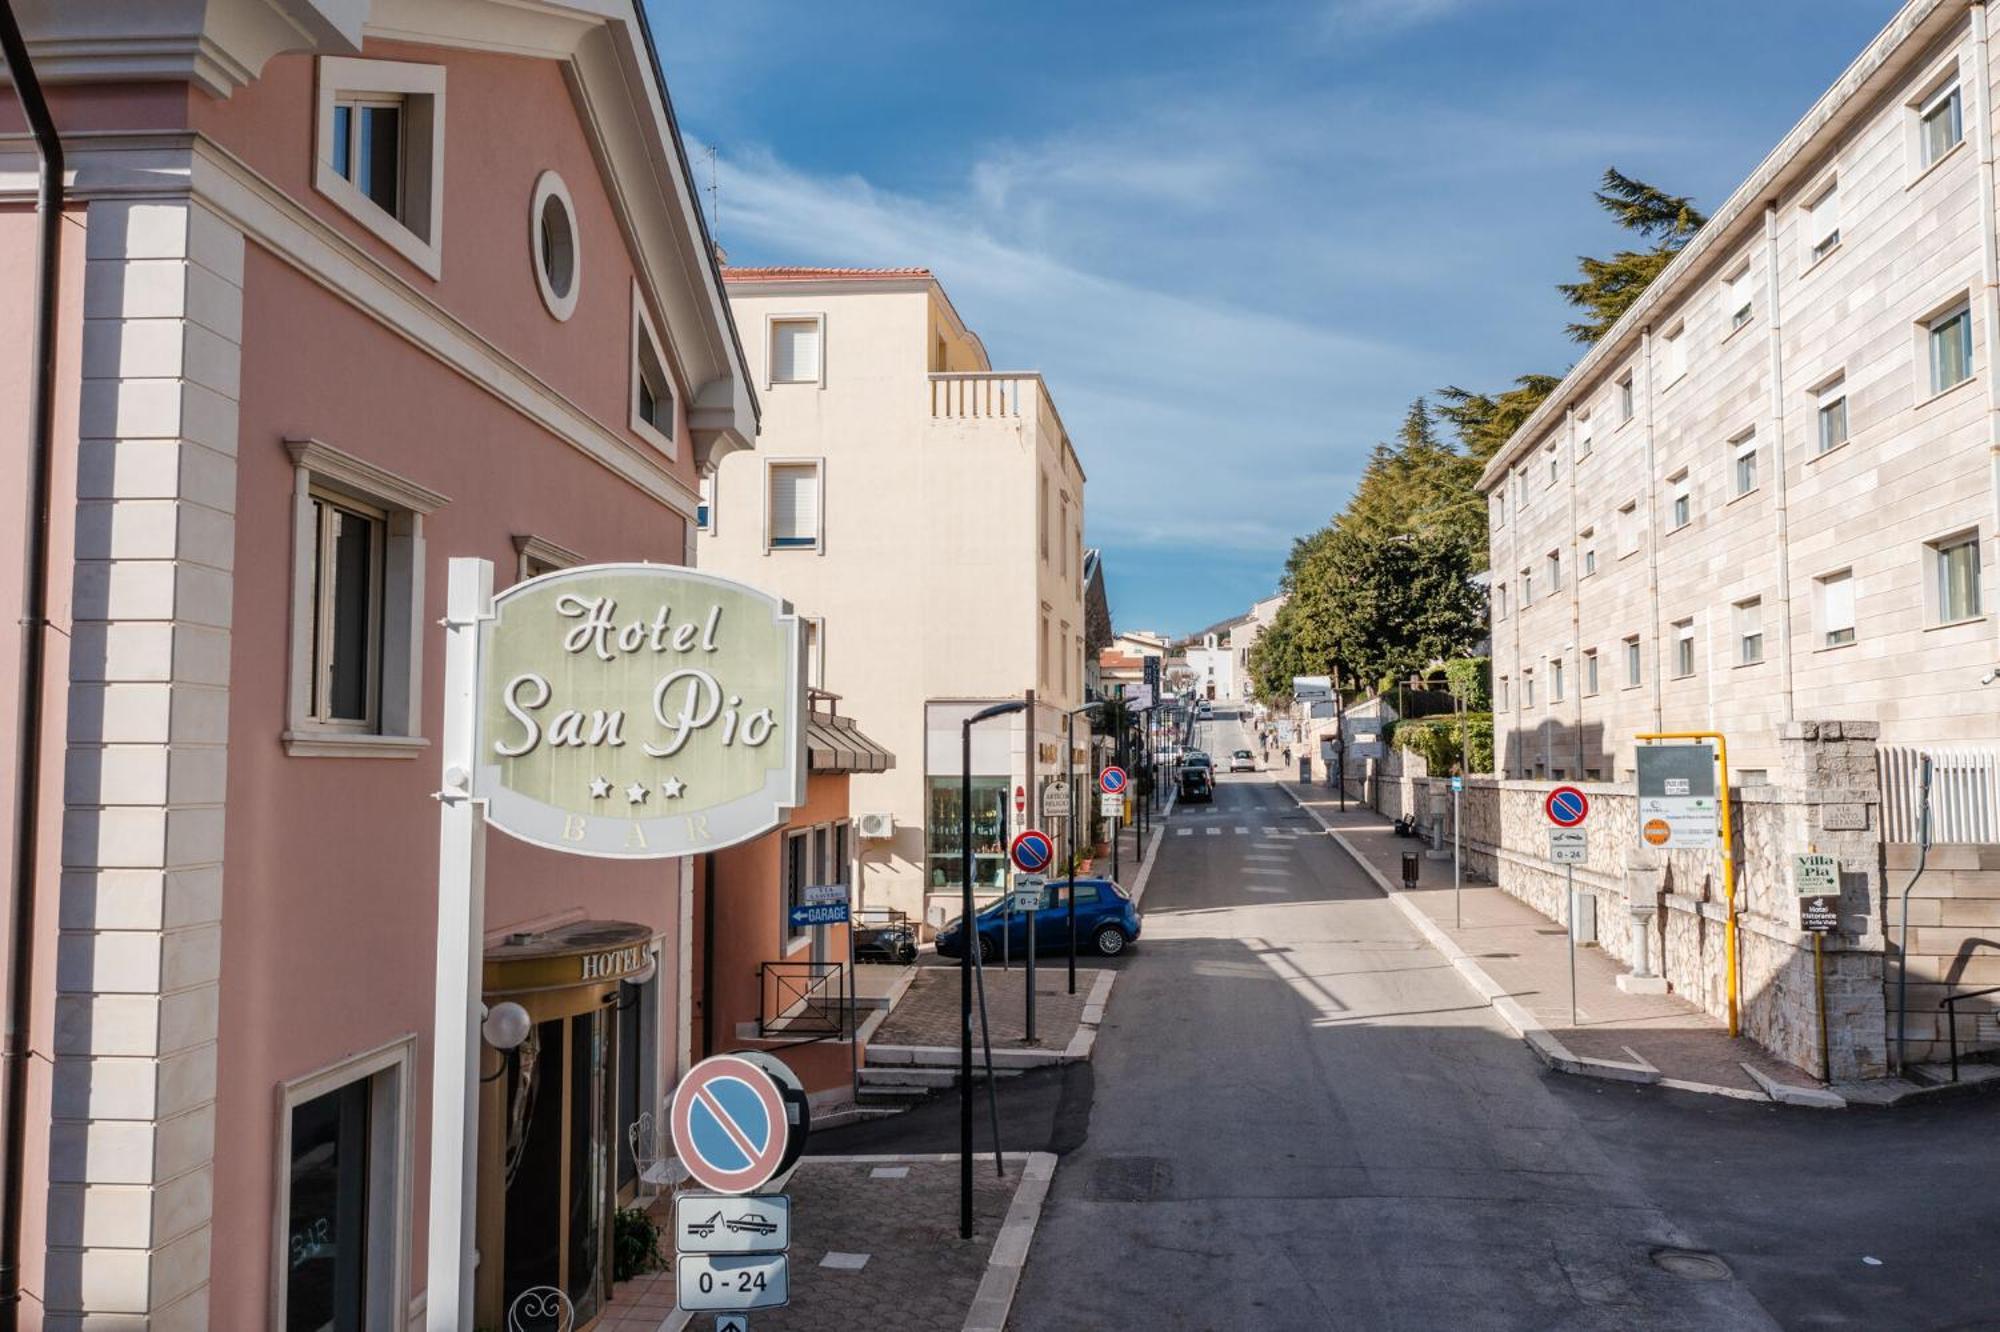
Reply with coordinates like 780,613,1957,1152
646,0,1896,632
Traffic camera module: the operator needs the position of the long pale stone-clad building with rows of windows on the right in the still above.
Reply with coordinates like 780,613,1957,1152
1480,0,2000,782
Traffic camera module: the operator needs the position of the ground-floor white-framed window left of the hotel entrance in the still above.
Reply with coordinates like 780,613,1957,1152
270,1036,416,1330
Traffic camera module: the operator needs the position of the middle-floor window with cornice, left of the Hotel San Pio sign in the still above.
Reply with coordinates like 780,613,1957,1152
284,440,446,756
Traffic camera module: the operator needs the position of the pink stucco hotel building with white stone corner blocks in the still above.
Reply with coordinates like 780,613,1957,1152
0,0,756,1330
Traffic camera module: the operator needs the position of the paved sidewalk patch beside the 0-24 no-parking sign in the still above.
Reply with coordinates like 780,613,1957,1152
614,1156,1026,1332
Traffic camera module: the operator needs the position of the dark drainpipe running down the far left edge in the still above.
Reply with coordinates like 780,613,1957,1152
0,0,62,1330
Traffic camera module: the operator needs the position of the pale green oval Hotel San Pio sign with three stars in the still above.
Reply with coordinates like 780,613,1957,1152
472,564,806,860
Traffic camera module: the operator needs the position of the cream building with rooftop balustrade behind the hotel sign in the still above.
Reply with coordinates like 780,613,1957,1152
696,268,1088,924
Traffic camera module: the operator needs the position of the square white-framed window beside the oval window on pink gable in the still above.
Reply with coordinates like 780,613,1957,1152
312,56,444,278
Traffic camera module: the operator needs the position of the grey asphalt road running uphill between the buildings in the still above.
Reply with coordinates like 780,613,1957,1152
814,704,2000,1332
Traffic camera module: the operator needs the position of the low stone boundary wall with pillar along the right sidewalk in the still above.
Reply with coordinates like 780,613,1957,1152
1412,722,1888,1078
